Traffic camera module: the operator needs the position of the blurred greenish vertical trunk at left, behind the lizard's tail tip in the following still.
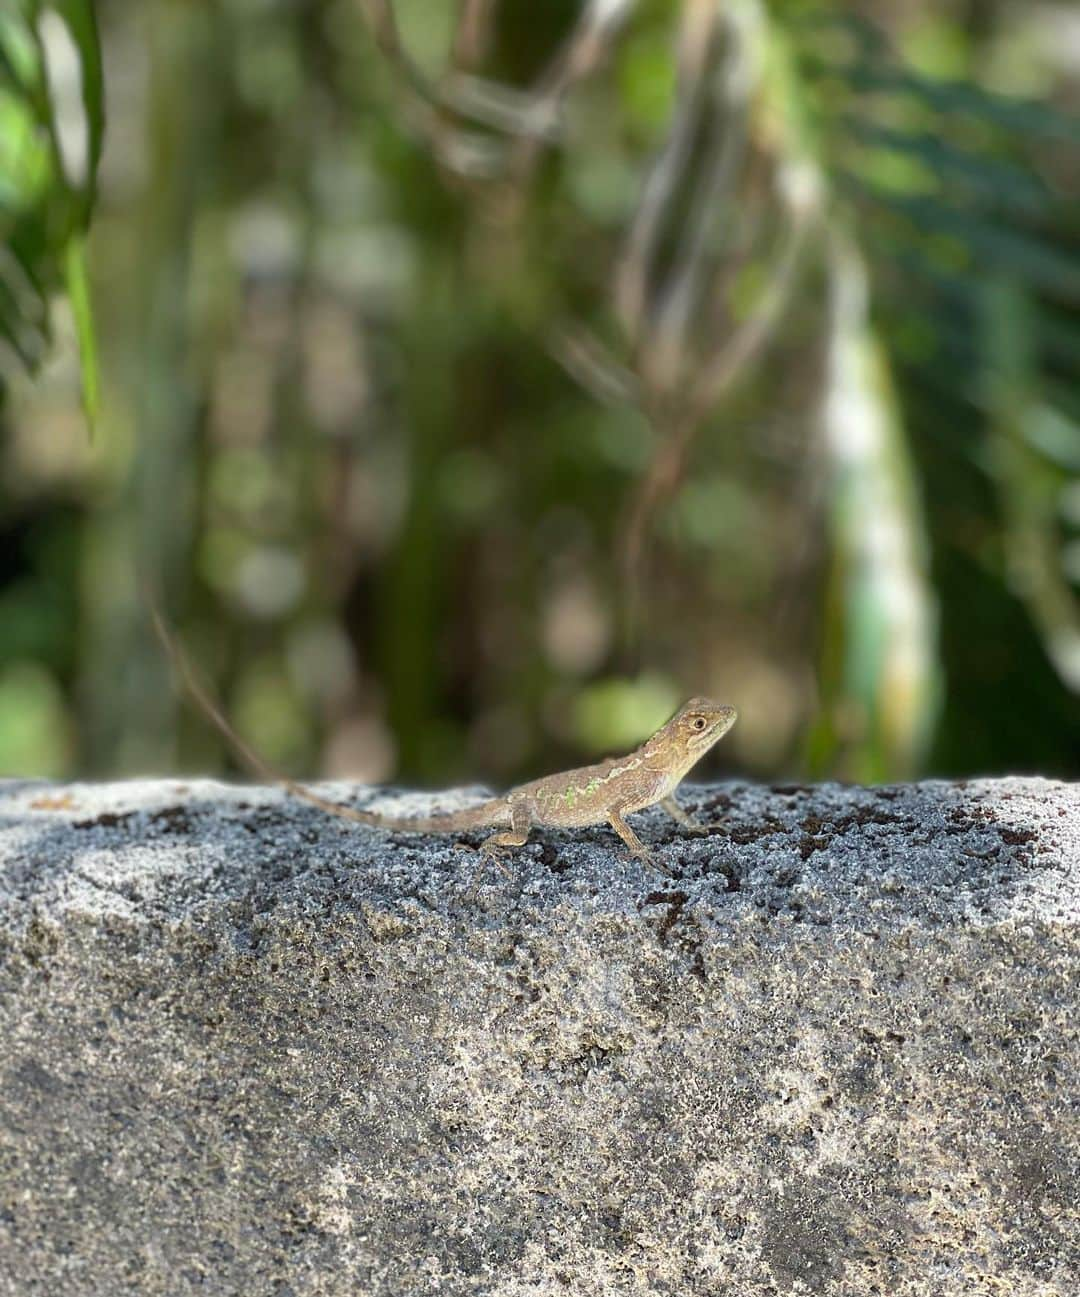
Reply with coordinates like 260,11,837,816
82,0,228,773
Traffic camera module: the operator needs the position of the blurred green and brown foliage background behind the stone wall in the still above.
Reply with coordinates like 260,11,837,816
0,0,1080,783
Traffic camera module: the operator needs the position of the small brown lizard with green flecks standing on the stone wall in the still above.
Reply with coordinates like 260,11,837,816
153,608,738,861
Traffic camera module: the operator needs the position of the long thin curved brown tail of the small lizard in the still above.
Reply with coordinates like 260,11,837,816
150,601,508,833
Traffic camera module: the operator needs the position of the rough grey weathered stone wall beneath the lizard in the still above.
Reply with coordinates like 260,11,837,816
0,779,1080,1297
